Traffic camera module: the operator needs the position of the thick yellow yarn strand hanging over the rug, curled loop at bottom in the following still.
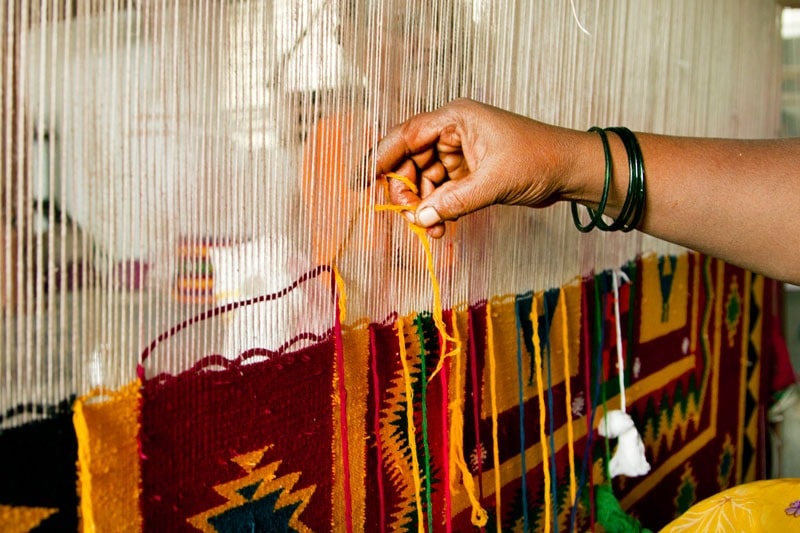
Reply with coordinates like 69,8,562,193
448,313,489,527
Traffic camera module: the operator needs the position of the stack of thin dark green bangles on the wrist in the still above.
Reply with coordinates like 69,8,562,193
572,126,645,233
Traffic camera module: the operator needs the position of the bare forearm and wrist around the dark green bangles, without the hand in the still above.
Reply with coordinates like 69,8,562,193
565,133,800,283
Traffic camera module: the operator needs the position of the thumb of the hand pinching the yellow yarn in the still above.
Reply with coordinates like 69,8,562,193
416,173,494,228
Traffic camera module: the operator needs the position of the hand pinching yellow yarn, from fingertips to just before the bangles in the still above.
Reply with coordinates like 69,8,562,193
374,100,586,237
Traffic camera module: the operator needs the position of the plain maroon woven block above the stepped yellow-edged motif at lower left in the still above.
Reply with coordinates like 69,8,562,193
141,339,334,531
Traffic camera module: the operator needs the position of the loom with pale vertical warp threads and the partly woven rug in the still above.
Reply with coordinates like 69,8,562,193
0,0,780,531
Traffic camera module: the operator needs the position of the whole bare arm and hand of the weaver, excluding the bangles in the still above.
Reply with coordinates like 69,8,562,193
374,100,800,284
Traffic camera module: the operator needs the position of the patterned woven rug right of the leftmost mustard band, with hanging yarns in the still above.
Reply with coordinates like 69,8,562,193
130,254,766,531
